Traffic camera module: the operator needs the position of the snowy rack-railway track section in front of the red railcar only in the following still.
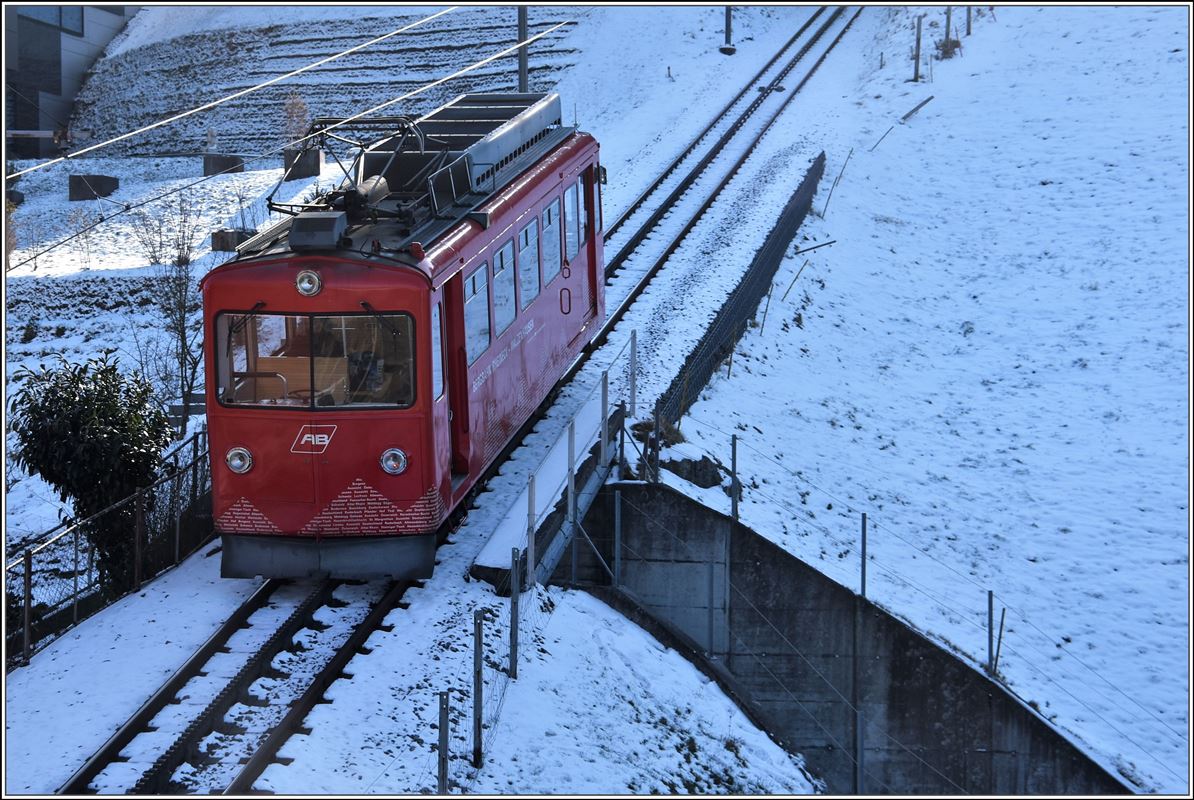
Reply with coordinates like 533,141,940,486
60,580,410,794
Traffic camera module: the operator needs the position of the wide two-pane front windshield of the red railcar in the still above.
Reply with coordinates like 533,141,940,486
216,313,414,410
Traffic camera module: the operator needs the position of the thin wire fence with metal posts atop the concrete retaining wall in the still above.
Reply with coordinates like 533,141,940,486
623,418,1188,792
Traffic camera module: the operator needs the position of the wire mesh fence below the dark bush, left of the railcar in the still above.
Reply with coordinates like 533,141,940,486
5,431,211,669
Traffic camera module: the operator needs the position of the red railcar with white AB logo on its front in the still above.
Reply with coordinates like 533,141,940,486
202,94,604,577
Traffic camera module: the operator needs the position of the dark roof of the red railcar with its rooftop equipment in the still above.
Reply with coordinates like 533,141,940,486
229,92,577,278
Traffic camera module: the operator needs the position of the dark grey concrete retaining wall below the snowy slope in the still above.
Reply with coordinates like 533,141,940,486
563,484,1131,794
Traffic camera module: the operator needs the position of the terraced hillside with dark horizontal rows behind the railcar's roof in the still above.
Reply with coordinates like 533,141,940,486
72,7,577,154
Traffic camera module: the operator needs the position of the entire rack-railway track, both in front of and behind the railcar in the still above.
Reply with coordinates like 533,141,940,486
60,7,861,794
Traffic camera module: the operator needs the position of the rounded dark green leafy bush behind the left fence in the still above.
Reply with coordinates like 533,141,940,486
10,351,172,595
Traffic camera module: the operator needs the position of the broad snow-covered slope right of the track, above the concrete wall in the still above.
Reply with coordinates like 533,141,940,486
663,7,1189,793
